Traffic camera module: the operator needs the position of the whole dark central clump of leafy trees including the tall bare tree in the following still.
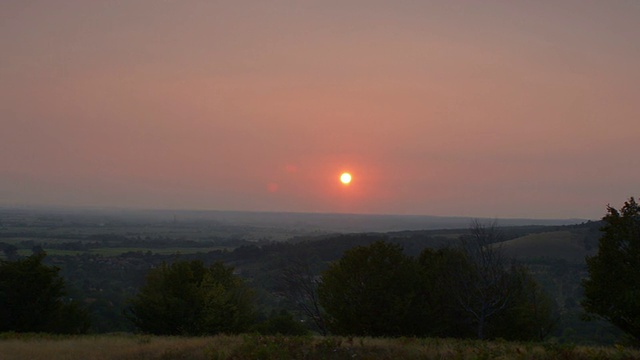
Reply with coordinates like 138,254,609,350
319,239,556,340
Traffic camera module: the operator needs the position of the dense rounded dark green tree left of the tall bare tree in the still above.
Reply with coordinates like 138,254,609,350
318,241,418,336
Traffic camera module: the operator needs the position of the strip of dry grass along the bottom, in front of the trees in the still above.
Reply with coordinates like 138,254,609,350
0,334,640,360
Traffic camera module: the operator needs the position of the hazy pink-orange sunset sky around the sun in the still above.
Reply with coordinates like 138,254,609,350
0,0,640,219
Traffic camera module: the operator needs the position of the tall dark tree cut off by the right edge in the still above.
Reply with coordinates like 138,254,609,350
582,197,640,341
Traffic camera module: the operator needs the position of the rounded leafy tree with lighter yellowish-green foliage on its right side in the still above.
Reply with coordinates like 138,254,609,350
128,260,254,335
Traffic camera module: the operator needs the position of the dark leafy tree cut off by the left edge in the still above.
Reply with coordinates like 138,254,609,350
0,252,89,334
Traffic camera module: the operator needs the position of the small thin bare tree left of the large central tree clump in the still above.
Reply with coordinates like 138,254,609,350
280,260,327,335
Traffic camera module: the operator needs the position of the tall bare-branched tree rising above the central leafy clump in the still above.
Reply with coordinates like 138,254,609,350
457,220,514,339
